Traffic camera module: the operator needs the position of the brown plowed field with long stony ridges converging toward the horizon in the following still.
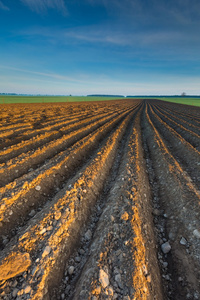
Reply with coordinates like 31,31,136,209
0,99,200,300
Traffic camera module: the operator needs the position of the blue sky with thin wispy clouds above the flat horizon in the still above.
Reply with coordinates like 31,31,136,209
0,0,200,95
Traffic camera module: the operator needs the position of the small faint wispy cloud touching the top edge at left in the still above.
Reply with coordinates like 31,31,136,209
21,0,67,15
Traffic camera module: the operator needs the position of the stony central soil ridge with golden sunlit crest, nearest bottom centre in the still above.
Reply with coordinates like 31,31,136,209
60,108,163,300
